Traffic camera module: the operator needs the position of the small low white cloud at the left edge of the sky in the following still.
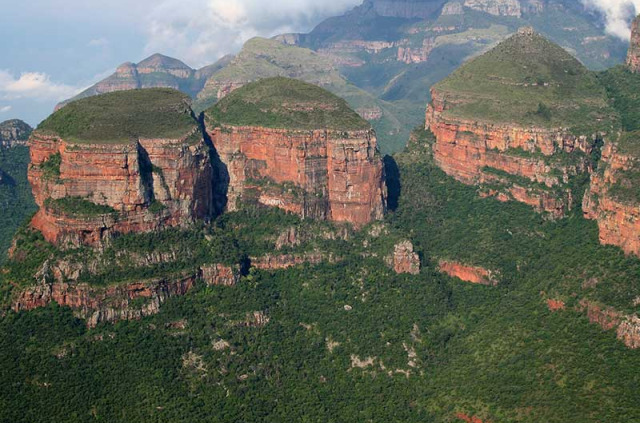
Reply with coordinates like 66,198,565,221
0,70,79,101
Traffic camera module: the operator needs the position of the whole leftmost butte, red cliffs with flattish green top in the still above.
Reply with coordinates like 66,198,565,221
29,90,213,246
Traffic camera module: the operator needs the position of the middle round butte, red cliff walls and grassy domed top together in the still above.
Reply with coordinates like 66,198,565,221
206,78,386,227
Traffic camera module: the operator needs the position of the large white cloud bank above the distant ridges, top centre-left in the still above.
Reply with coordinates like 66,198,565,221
145,0,362,66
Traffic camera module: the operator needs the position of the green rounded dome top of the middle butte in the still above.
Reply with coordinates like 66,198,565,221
206,77,370,130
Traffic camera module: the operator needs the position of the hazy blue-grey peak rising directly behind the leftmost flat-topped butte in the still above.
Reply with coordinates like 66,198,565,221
56,54,231,110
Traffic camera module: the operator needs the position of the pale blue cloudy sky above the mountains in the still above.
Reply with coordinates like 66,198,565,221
0,0,640,125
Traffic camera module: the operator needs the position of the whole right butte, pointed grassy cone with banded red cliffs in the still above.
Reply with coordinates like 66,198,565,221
426,28,614,217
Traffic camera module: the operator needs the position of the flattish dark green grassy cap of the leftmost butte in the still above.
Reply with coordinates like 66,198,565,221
38,88,197,143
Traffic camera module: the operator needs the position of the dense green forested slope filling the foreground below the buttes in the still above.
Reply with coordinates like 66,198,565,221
0,132,640,423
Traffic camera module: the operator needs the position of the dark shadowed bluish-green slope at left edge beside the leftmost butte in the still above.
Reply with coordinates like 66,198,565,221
0,146,36,264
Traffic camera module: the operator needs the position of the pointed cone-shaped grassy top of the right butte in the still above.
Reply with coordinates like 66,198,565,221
435,28,616,134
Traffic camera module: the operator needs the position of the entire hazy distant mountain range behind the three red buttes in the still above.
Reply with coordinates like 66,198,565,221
53,0,626,153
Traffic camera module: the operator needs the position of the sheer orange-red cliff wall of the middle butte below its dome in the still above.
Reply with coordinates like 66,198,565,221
207,126,386,227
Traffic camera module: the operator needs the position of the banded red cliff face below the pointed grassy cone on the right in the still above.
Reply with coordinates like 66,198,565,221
426,89,594,217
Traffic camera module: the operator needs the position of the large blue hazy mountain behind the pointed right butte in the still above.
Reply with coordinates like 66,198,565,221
277,0,626,152
